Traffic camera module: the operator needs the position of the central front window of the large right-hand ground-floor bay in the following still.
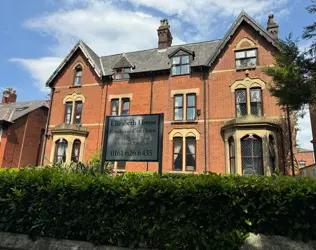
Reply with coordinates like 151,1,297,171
241,134,264,175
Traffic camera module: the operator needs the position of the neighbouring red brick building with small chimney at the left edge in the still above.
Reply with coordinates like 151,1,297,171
0,88,48,168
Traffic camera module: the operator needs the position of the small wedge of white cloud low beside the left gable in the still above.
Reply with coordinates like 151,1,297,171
9,57,62,93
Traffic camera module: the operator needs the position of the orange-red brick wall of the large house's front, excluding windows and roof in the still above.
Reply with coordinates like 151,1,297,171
46,24,290,173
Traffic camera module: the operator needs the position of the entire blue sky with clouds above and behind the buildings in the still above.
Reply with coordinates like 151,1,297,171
0,0,314,148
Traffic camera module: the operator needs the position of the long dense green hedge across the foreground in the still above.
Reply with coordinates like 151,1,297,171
0,168,316,249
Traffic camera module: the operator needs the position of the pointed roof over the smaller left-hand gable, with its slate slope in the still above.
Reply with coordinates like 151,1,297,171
46,40,103,86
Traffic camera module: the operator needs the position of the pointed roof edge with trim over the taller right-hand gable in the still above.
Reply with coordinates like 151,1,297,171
205,11,278,66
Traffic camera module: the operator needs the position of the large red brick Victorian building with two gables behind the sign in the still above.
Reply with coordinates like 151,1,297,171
44,12,288,174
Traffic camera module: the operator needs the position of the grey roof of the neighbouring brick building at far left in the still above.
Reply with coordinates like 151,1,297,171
0,100,49,123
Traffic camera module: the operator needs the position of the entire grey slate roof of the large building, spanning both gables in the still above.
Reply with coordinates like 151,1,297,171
46,11,278,86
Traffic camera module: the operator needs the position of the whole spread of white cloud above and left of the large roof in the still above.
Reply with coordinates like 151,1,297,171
11,0,288,92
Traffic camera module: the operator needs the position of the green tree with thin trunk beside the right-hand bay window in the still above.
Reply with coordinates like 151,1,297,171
262,35,312,176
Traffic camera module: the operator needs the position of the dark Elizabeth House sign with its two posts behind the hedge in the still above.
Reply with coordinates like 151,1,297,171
101,114,164,175
